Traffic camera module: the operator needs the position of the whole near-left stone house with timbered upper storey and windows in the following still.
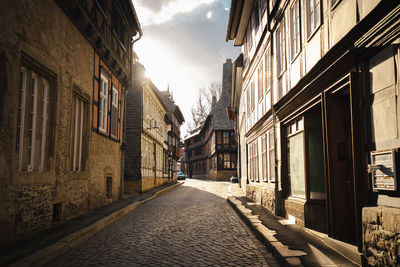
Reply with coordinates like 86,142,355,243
0,0,141,249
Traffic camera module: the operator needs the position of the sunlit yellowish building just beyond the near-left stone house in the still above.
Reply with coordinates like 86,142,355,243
124,59,170,194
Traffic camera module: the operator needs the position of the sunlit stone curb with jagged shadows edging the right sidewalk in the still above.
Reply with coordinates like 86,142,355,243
227,197,307,266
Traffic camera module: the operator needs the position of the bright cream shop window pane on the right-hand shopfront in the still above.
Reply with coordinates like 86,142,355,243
287,118,306,198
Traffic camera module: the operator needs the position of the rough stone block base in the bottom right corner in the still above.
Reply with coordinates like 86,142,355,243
362,206,400,266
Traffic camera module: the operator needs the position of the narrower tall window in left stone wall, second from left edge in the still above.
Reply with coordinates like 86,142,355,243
70,94,88,171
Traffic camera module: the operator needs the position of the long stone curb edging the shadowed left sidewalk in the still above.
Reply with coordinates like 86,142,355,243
9,182,183,267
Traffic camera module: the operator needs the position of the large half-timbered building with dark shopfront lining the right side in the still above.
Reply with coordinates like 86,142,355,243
226,0,400,266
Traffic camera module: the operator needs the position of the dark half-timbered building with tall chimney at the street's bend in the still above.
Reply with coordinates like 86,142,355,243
185,59,237,180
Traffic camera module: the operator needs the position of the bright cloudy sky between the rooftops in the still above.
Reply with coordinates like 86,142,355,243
132,0,240,137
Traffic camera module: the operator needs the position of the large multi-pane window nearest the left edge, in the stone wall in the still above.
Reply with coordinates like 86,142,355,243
16,67,54,171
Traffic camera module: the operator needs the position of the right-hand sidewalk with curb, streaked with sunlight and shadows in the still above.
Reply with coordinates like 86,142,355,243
227,184,361,266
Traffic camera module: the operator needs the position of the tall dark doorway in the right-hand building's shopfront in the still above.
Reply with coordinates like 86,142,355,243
325,85,356,244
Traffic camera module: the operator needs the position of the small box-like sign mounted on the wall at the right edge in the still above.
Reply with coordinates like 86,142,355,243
368,149,397,191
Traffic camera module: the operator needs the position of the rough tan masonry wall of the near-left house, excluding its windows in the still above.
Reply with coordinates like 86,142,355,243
0,0,123,246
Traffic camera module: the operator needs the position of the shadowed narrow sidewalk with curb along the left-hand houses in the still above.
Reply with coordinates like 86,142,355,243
0,182,182,266
